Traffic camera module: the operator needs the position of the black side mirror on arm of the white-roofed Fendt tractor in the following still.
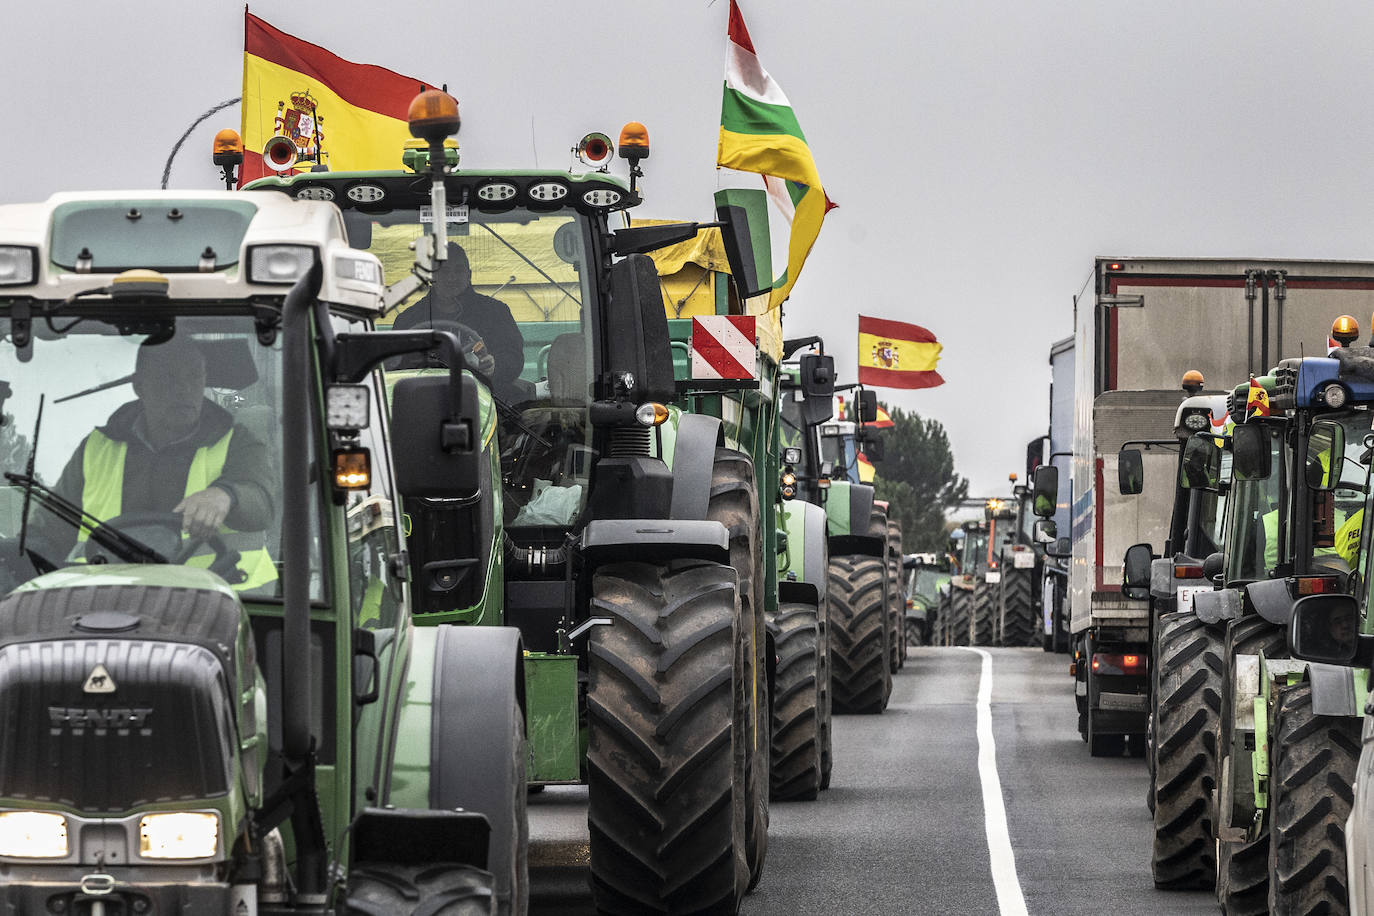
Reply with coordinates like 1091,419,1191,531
392,369,482,499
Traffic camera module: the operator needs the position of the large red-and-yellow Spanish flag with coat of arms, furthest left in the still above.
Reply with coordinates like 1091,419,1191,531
239,10,427,185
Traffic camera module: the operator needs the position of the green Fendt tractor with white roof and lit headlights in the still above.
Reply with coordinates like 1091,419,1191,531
0,191,526,916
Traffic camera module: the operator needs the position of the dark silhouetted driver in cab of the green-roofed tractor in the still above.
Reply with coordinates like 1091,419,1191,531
389,242,525,398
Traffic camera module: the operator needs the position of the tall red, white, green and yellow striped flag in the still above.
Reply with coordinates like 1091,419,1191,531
716,0,835,309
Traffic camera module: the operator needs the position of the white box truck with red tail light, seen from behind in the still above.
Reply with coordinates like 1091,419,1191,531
1061,258,1374,755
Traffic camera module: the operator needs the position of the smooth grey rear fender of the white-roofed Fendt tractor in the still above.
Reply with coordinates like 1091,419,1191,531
429,626,525,889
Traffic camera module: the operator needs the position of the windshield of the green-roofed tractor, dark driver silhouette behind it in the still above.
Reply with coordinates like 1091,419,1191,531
349,207,595,529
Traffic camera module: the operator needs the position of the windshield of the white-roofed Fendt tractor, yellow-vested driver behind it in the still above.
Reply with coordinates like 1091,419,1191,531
0,317,313,599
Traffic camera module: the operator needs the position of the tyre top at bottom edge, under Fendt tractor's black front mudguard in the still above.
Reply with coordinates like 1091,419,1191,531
344,862,496,916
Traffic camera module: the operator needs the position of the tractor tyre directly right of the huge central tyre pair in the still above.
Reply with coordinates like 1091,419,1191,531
769,603,820,802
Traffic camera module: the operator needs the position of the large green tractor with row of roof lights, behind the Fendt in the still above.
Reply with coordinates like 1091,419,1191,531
250,111,785,913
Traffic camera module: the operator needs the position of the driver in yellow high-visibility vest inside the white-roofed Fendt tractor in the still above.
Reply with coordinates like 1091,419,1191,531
43,338,276,589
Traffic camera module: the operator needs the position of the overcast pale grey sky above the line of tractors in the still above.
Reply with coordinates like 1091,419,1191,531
8,0,1374,494
